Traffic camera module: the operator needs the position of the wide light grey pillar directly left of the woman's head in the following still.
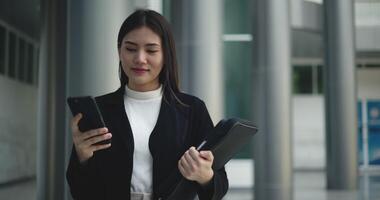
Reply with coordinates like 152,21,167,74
65,0,140,199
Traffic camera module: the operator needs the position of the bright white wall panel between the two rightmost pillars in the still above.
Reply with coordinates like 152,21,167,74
293,95,325,169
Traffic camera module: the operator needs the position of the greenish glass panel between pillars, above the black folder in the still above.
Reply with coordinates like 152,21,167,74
223,0,253,159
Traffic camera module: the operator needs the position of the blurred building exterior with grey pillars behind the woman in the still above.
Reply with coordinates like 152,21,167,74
0,0,380,200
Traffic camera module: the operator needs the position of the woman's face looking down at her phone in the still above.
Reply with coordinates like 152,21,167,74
119,26,163,92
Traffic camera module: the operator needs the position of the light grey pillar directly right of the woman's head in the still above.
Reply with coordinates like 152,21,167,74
171,0,224,123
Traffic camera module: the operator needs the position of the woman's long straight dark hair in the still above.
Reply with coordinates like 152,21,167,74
117,9,181,102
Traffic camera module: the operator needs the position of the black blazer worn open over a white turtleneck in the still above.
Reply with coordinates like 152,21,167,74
66,87,228,200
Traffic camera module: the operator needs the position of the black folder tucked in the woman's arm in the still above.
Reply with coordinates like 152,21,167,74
165,118,257,200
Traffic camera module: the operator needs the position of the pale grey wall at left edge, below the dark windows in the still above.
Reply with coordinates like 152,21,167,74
0,75,37,183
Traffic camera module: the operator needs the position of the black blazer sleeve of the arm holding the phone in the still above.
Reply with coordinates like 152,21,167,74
66,146,105,200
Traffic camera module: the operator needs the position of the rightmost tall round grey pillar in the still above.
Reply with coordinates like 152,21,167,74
324,0,358,189
